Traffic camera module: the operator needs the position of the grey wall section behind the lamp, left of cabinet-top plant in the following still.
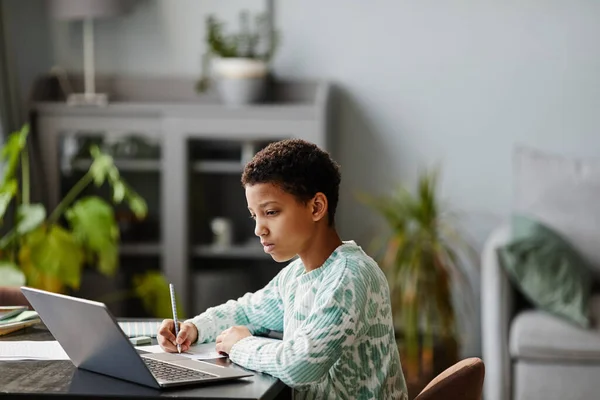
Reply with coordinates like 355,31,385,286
52,0,266,76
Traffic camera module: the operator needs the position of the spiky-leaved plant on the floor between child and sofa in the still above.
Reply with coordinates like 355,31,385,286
362,171,473,385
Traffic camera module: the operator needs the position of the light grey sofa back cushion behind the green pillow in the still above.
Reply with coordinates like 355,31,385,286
513,147,600,277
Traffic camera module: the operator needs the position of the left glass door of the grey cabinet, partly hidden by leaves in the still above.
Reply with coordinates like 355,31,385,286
58,130,162,317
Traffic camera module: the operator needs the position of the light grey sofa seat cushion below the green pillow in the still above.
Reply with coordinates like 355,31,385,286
509,310,600,362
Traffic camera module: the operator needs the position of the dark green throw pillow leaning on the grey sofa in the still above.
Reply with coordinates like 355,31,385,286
497,215,592,328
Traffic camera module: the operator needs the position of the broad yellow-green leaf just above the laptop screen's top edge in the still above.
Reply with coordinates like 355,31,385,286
22,225,84,289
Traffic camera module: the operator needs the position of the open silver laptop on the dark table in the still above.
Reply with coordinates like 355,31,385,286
21,287,252,389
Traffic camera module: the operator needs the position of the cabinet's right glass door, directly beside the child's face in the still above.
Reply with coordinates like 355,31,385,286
188,139,285,314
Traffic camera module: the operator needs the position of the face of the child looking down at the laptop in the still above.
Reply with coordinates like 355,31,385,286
246,183,315,262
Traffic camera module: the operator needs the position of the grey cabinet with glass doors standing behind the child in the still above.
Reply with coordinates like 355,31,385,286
33,78,330,316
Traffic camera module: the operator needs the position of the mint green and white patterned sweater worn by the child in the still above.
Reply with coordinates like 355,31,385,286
188,241,408,400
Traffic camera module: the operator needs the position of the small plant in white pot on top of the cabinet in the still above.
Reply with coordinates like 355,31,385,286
197,11,277,106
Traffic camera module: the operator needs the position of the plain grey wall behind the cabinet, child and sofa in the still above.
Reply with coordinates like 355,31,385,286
38,0,600,355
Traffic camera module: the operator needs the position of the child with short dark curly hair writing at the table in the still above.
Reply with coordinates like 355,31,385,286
158,139,407,399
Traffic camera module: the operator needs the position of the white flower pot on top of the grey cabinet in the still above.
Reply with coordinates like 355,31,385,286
213,58,268,106
